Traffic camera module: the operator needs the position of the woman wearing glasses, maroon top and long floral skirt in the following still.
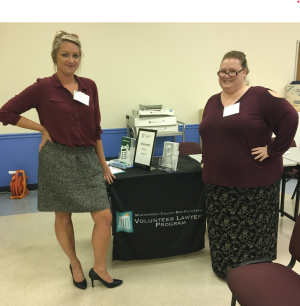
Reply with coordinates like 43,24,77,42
199,51,298,278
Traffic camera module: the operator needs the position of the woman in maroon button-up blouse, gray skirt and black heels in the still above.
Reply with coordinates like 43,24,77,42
0,31,122,289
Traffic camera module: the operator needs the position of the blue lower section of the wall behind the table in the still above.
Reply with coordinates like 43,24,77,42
0,124,199,191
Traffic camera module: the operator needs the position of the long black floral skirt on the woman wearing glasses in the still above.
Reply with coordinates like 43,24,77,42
205,180,280,278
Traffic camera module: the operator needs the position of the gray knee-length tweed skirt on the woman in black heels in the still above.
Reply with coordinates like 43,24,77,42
38,141,110,213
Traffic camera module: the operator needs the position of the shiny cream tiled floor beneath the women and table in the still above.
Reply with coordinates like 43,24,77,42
0,182,300,306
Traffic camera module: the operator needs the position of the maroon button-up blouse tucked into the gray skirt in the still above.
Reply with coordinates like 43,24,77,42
0,74,102,147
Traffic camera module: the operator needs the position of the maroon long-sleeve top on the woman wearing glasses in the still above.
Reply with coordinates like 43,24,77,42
199,86,299,188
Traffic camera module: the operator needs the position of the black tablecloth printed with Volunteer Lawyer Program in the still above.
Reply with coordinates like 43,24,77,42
109,156,206,260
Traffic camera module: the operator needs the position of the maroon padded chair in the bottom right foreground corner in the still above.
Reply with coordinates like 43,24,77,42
226,216,300,306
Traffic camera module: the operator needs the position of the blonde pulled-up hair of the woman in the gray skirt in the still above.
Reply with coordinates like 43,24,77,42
51,31,83,71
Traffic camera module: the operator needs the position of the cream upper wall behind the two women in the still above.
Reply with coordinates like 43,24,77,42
0,22,300,143
